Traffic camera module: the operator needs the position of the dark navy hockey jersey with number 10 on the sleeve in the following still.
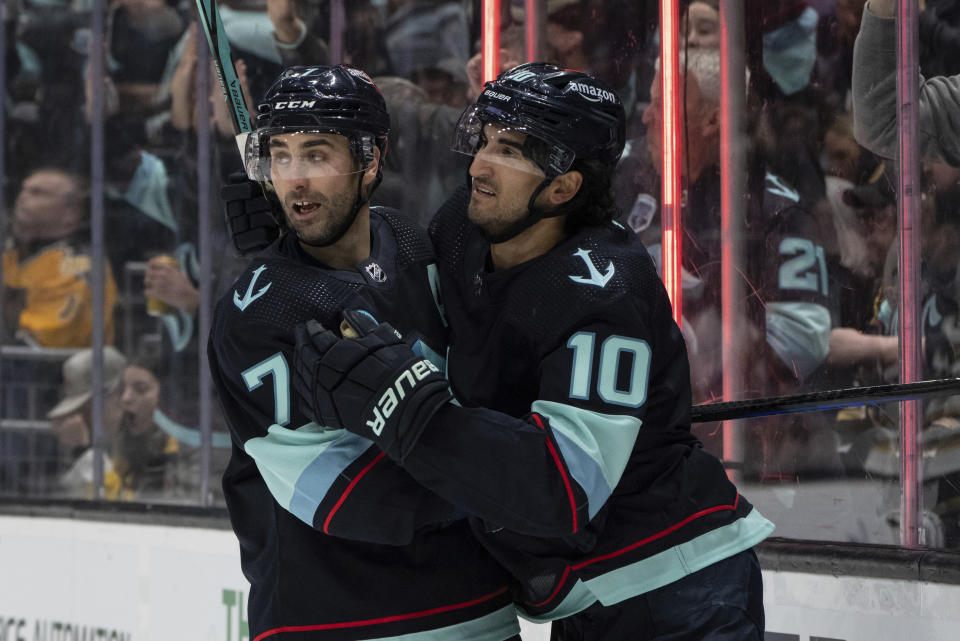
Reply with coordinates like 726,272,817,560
390,192,773,618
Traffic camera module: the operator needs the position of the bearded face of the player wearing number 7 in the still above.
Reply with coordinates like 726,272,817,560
270,133,362,246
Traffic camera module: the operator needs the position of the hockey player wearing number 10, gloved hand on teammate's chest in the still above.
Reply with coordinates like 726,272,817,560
295,63,773,641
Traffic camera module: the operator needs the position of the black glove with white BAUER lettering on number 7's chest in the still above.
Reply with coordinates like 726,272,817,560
294,311,453,463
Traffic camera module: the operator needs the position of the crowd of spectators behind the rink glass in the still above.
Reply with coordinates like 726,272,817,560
0,0,960,544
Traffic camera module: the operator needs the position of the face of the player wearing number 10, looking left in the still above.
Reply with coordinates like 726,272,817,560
467,124,544,237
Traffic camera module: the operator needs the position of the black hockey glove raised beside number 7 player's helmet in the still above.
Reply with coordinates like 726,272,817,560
220,172,280,256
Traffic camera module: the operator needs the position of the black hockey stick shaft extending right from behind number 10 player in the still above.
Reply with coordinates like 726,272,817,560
690,378,960,423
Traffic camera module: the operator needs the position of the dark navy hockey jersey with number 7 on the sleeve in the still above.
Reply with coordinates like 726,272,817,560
208,208,518,641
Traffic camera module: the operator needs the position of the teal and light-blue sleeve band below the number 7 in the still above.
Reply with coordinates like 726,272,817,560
244,423,372,527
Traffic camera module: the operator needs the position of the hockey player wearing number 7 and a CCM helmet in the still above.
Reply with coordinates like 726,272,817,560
208,65,519,641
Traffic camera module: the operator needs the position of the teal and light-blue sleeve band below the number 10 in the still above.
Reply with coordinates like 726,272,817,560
531,401,642,519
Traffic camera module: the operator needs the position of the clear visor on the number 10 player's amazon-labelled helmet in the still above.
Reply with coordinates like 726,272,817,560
453,105,574,178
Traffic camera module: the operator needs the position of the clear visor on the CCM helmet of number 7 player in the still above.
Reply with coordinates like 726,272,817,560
244,128,373,181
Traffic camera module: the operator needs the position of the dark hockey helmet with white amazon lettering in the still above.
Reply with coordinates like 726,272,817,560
453,62,626,179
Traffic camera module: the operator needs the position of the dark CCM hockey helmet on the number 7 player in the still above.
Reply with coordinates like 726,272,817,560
244,64,390,181
